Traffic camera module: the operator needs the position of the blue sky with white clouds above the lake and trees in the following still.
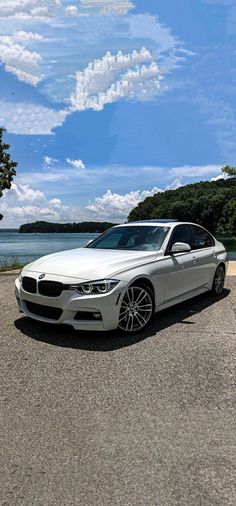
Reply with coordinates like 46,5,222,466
0,0,236,228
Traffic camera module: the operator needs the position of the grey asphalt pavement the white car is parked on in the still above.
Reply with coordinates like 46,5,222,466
0,275,236,506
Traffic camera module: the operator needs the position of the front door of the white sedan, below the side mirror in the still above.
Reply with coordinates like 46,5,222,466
164,225,198,304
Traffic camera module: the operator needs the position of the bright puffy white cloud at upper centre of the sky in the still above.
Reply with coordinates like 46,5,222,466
71,48,163,111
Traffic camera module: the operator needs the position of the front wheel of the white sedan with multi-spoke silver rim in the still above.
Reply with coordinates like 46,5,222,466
118,283,154,334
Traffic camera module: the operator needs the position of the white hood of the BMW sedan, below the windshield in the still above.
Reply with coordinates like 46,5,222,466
25,248,161,281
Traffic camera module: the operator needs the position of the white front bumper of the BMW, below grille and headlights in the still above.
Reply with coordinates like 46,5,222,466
15,273,126,331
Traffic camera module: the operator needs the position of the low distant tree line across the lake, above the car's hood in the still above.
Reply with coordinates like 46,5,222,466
19,221,117,234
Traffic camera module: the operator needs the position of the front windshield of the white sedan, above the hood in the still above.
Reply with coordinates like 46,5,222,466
87,226,169,251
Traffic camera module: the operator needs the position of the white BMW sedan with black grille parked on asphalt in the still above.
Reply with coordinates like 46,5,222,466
16,220,227,333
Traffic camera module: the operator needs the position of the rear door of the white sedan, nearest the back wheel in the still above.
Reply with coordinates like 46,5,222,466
191,225,217,288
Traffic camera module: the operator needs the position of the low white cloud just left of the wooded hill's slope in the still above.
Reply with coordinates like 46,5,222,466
86,188,163,219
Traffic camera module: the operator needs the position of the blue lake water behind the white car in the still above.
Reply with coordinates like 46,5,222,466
0,231,236,265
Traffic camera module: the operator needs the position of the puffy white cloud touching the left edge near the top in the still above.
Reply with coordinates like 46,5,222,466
0,32,43,86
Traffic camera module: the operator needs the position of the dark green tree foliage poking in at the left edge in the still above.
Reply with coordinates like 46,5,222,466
0,128,17,220
